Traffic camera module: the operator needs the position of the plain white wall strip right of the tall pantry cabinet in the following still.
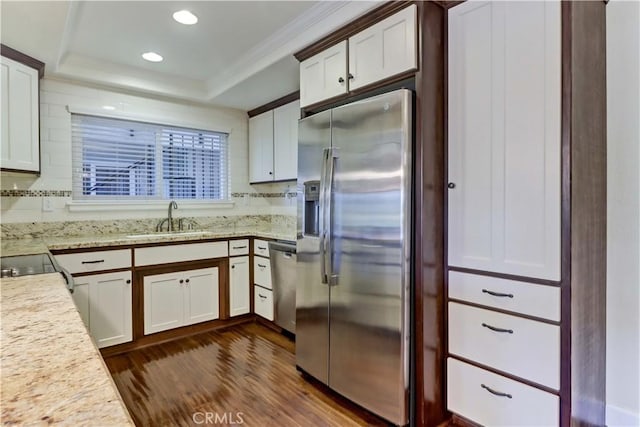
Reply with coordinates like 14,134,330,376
606,0,640,426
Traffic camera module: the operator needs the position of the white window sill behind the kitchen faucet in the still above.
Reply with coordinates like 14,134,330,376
67,199,235,212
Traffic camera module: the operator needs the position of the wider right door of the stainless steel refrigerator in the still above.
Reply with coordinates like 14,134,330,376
329,90,411,425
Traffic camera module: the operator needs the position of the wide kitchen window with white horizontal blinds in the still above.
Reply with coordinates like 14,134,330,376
71,114,229,200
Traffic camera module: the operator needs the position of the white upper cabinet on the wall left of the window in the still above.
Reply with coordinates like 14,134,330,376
0,56,40,173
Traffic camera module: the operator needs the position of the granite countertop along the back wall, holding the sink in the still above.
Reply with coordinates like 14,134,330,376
1,230,295,256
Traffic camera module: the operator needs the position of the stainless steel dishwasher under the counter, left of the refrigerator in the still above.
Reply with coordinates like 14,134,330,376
269,241,296,334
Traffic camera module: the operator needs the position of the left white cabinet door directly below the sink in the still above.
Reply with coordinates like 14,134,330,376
143,273,185,335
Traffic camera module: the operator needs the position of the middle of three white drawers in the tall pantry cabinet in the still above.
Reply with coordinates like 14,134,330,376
449,303,560,390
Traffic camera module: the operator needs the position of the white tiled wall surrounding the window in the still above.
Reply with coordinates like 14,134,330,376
0,78,295,223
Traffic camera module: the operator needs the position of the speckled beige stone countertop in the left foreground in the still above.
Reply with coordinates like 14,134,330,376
0,273,133,426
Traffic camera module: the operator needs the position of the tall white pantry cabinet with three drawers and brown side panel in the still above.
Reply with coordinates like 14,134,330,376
445,1,606,425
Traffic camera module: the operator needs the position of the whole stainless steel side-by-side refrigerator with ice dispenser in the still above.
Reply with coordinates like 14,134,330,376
296,89,412,425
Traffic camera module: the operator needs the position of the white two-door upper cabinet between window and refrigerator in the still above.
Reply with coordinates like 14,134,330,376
249,101,300,183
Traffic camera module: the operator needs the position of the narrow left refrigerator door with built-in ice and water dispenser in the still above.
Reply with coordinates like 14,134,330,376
296,111,331,384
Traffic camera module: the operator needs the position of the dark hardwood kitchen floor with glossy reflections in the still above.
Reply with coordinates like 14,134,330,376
105,322,385,427
